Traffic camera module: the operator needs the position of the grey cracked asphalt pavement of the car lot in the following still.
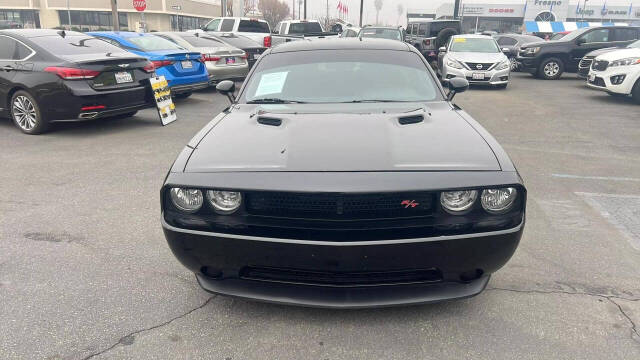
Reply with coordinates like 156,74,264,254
0,74,640,360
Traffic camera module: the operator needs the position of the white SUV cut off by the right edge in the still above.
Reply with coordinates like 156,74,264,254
587,41,640,104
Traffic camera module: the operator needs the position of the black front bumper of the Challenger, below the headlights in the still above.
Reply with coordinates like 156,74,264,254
162,216,524,308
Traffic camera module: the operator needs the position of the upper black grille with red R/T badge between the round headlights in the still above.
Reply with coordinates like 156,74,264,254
246,191,434,219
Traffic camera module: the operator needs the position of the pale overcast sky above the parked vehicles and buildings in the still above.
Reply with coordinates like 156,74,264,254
292,0,640,25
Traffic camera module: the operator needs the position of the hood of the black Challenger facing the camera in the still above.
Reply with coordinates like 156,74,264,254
185,101,500,172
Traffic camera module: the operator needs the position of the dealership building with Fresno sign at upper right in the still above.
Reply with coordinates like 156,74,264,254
435,0,640,33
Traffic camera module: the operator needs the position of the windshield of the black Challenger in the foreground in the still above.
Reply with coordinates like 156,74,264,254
240,50,440,103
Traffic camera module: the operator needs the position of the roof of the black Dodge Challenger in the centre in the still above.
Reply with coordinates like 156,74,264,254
271,38,411,54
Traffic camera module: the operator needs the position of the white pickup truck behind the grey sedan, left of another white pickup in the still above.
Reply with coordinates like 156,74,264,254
200,17,271,47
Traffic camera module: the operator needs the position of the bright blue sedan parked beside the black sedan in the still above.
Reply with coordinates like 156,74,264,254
87,31,209,98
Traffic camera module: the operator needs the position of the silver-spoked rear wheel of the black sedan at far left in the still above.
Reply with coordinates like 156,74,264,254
9,90,50,135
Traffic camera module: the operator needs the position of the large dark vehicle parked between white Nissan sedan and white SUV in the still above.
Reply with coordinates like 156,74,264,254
517,26,640,80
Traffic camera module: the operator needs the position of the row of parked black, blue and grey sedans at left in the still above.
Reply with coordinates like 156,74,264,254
0,29,264,134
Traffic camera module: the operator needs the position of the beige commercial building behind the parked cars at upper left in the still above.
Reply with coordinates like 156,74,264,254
0,0,220,31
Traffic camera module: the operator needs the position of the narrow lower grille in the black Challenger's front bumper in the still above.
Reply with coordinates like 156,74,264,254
240,267,442,287
